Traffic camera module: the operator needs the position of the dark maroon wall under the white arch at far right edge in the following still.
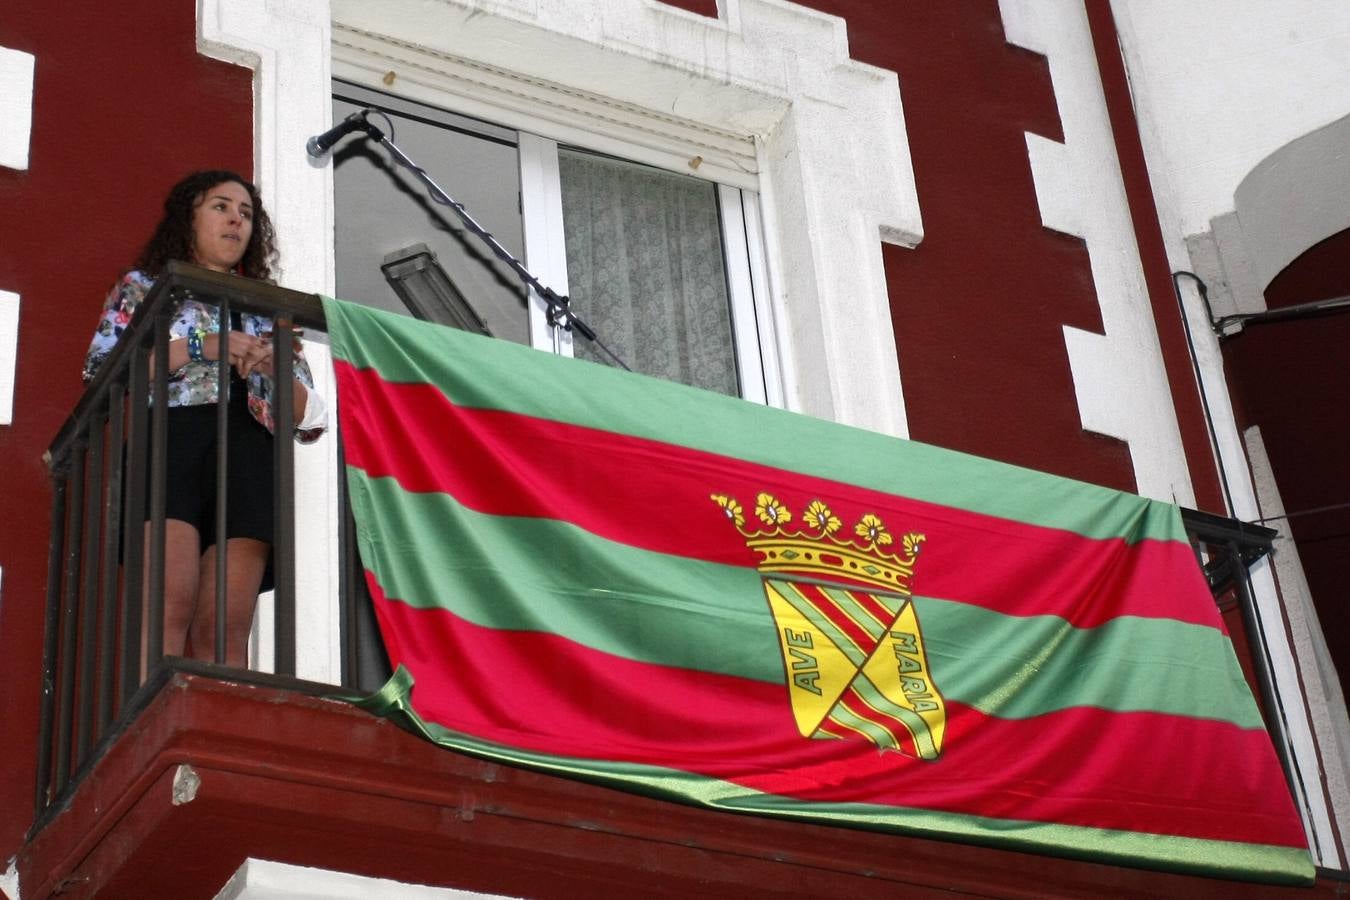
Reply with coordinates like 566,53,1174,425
1223,231,1350,694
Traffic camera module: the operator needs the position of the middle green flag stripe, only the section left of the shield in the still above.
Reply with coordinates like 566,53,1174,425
347,468,783,683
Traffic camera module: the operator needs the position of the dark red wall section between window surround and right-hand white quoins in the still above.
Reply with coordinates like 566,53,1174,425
793,0,1134,490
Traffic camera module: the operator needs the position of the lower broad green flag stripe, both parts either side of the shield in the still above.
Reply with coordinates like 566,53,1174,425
348,468,1261,727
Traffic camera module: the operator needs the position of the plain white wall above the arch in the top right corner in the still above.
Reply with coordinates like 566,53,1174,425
1111,0,1350,235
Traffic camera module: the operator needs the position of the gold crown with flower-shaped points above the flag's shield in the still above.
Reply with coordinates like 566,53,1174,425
711,493,925,595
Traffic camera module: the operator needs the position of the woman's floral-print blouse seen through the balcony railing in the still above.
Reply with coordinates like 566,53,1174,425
84,270,324,444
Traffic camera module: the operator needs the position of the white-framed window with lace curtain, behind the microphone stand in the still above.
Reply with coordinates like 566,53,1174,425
333,82,782,402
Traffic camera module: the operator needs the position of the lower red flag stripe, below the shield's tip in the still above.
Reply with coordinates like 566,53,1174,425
367,573,1305,847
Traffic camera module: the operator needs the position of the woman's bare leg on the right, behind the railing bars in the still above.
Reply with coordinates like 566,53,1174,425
192,537,271,668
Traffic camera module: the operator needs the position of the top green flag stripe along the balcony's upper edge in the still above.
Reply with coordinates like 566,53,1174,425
324,300,1185,542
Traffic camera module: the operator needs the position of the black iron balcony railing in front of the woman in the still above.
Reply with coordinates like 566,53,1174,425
36,263,360,822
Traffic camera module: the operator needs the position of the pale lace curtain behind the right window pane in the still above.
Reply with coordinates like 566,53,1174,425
558,148,740,395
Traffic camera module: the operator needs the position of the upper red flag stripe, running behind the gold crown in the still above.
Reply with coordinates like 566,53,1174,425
335,360,1223,630
